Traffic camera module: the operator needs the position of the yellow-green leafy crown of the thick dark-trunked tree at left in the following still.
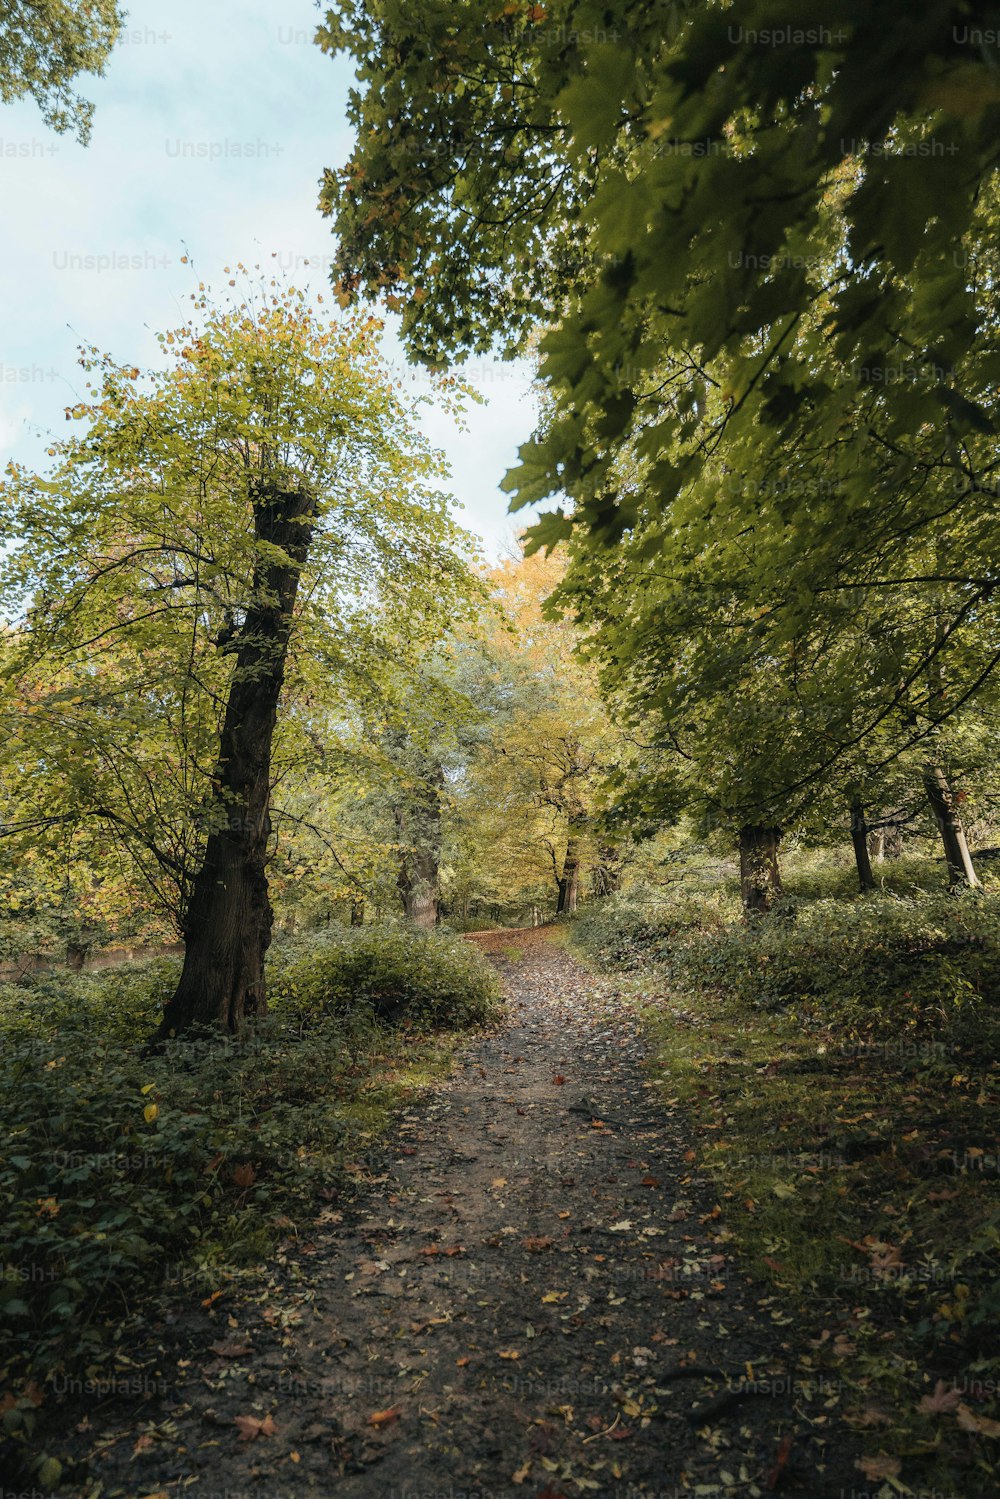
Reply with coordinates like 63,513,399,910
0,267,481,941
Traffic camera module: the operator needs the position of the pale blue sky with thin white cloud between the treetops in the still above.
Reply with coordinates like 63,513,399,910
0,0,535,556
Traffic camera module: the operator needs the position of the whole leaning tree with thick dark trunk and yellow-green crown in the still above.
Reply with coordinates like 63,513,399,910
4,278,472,1039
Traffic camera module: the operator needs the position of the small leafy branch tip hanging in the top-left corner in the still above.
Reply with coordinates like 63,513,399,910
0,0,124,144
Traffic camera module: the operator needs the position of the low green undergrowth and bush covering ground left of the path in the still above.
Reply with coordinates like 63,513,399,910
0,929,496,1378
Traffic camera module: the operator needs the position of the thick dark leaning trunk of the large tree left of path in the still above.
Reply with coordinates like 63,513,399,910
153,484,313,1043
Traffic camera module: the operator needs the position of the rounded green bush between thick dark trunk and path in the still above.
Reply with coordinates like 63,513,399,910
268,926,499,1031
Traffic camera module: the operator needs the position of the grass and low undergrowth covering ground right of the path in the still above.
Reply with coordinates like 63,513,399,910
577,872,1000,1495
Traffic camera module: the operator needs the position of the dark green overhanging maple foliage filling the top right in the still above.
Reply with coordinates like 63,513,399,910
318,0,1000,540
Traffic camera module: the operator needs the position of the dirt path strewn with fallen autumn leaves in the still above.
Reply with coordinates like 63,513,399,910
58,932,864,1499
